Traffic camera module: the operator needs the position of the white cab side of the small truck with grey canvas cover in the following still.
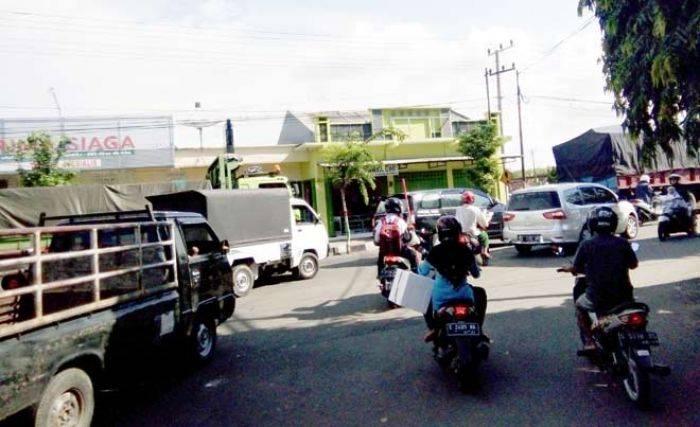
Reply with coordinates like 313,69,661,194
292,203,328,265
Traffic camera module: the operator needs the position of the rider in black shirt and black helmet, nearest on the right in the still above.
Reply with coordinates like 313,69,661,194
557,206,639,350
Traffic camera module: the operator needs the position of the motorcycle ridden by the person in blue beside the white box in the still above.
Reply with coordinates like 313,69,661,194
433,301,490,391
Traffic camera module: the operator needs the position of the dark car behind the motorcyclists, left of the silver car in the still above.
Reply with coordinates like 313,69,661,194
372,188,505,239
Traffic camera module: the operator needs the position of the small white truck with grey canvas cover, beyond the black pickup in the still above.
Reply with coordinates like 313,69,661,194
148,189,328,297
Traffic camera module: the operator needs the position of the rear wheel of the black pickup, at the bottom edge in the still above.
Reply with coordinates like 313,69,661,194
34,368,95,427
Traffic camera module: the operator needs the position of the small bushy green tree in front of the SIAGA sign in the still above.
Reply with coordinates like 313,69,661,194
13,132,75,187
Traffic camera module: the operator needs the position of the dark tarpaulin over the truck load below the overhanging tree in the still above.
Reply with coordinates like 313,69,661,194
552,127,700,182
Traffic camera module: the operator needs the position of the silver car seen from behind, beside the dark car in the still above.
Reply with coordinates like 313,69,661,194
503,183,639,254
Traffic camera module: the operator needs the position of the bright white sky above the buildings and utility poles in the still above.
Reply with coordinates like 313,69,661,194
0,0,621,168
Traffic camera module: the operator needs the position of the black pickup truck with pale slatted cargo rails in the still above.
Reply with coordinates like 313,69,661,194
0,210,235,426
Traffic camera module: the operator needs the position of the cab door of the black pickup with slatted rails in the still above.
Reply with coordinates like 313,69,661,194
180,221,233,309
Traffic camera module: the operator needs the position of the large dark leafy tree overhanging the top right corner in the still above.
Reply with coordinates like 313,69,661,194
578,0,700,164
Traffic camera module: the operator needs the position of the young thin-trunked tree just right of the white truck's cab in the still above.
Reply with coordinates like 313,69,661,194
324,128,406,253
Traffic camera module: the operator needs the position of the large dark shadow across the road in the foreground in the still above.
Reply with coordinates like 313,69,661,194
72,280,700,426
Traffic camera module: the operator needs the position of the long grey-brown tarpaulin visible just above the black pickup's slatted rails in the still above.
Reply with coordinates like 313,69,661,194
0,181,211,229
